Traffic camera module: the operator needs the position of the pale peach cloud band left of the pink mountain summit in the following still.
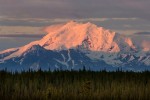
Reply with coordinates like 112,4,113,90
0,26,46,38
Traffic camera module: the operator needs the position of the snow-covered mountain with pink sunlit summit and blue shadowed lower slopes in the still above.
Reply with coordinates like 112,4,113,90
0,21,150,71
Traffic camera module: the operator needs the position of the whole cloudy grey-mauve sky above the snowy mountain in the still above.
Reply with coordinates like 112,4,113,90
0,0,150,50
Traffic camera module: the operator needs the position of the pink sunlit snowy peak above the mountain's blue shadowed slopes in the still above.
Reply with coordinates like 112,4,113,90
39,21,132,52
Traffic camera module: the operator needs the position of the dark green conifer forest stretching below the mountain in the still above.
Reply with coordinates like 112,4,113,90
0,70,150,100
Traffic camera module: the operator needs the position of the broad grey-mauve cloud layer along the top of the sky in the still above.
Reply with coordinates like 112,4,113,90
0,0,150,20
